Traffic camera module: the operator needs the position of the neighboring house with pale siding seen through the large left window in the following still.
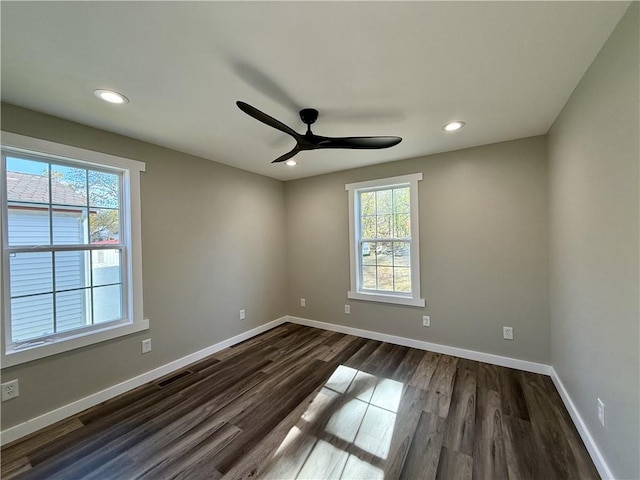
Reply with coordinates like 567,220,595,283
6,171,121,342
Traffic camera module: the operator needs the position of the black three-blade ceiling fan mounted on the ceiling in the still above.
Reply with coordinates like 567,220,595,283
236,101,402,163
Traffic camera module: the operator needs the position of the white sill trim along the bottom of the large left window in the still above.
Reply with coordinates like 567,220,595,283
2,319,149,368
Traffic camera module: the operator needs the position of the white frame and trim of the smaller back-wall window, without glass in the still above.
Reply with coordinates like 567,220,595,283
345,173,425,307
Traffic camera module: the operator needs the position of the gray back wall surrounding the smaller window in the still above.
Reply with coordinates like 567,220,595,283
285,137,549,363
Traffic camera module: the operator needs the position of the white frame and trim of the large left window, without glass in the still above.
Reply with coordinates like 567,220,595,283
0,131,149,368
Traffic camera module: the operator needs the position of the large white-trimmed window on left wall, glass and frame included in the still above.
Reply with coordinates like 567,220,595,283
1,132,148,366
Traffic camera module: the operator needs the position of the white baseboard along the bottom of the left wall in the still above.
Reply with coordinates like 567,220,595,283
0,317,287,445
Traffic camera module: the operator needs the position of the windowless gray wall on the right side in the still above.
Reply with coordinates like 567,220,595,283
549,2,640,479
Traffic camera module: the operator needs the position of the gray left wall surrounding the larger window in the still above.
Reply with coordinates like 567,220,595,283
2,104,286,429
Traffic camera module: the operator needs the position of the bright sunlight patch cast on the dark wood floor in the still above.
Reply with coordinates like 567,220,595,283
263,365,404,480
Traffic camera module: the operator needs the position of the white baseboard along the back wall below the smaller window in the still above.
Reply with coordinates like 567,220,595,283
287,316,551,375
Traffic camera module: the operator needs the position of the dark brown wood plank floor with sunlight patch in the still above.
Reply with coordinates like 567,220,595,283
2,324,599,480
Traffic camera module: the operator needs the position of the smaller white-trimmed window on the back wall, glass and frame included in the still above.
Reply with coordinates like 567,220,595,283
345,173,425,307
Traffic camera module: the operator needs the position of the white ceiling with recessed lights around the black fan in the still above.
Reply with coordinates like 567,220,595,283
1,1,629,180
